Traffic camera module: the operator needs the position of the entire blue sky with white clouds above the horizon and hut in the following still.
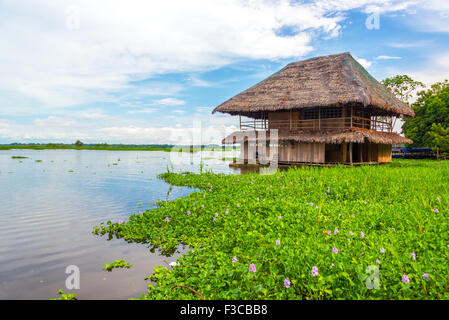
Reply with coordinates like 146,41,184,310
0,0,449,144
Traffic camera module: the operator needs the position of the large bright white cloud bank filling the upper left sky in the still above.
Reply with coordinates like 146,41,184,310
0,0,370,112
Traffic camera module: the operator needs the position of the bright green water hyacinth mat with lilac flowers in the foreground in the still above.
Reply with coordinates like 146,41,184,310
93,160,449,299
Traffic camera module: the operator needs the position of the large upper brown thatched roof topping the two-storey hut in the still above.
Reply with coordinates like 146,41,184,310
212,52,414,118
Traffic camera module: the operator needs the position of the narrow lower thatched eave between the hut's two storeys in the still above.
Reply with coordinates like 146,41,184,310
222,128,413,145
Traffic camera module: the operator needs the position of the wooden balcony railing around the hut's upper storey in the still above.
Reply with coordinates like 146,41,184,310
240,116,393,132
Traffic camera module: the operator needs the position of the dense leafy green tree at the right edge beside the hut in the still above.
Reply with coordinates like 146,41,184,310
402,80,449,149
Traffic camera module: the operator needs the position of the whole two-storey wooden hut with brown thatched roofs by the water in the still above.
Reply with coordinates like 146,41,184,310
212,52,414,164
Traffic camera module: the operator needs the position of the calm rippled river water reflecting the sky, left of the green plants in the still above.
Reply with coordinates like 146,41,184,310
0,150,238,299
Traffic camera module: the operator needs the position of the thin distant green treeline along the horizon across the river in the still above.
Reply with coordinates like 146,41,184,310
0,143,238,152
